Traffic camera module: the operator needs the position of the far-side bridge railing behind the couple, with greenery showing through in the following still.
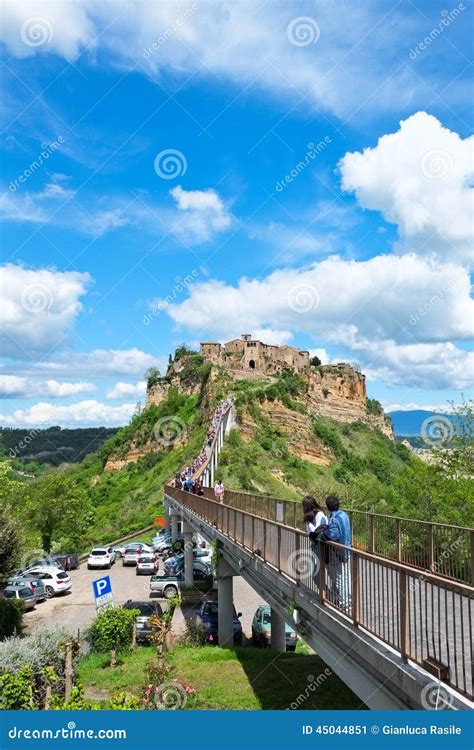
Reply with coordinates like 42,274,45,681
192,488,474,585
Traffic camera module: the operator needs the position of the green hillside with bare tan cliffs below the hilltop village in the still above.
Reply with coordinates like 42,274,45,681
0,354,474,560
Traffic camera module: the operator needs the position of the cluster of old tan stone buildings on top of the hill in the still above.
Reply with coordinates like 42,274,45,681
201,333,309,375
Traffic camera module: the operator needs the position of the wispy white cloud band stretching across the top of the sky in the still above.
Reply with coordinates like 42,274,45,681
2,0,465,116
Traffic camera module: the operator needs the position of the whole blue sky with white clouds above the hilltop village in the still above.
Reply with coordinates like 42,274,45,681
0,0,474,426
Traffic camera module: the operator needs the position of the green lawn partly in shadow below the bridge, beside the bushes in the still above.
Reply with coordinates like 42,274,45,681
77,646,364,710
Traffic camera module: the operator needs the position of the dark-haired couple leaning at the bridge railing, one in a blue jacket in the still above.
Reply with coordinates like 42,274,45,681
302,495,352,609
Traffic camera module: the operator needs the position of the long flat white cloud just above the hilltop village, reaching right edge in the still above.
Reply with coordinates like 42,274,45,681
166,255,474,345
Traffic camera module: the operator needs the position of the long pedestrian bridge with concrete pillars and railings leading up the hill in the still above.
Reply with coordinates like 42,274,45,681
165,400,474,709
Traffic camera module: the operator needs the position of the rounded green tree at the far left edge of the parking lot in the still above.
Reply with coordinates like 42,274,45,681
26,471,93,552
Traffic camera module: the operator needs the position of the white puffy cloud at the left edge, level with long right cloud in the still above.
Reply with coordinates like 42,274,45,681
0,264,91,358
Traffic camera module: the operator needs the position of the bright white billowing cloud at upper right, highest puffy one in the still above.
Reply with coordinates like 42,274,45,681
339,112,474,264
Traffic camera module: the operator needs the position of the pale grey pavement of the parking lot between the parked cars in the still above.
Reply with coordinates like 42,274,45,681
24,560,262,637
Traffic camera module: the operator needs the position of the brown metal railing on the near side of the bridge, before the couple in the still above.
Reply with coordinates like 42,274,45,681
165,486,473,698
